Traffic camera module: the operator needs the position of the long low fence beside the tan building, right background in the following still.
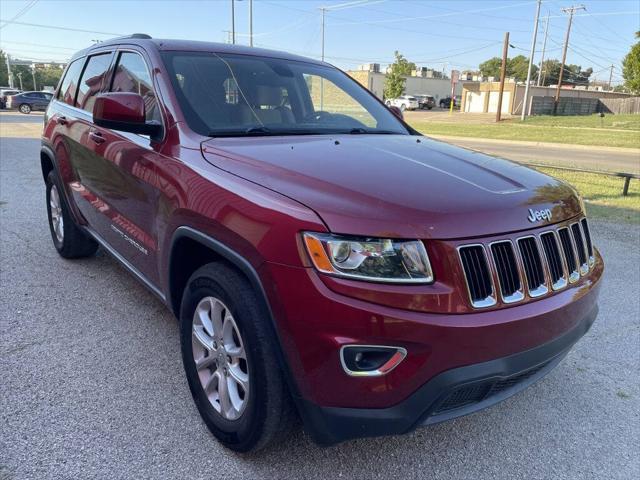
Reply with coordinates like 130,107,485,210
531,97,640,115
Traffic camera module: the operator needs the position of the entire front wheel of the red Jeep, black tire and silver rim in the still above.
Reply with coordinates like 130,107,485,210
180,263,295,452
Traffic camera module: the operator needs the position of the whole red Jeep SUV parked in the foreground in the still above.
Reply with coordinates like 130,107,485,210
40,34,603,451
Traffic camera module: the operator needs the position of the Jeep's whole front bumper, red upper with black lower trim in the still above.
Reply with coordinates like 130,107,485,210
260,251,604,444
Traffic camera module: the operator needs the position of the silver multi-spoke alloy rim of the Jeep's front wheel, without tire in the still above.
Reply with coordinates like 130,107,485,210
191,297,250,420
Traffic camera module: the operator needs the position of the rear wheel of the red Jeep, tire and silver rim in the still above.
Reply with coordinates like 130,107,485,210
46,170,98,258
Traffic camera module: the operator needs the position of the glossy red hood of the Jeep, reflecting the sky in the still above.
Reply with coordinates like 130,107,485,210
202,135,581,239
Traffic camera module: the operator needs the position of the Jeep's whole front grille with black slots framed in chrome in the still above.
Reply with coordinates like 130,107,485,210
458,218,595,308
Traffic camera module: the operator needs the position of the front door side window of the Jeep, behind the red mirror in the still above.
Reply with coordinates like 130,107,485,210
111,52,160,122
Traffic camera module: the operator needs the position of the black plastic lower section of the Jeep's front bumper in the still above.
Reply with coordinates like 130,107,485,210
303,306,598,445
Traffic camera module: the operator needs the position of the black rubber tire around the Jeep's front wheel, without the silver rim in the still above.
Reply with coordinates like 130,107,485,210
180,263,295,452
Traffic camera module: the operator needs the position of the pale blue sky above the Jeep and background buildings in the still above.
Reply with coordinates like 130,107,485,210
0,0,640,83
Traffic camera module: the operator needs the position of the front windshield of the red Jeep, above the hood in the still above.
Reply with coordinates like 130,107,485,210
163,52,409,136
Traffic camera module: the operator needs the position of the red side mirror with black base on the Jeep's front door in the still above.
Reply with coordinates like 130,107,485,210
93,92,162,137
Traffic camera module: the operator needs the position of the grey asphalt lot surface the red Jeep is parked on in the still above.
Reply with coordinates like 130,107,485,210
0,119,640,480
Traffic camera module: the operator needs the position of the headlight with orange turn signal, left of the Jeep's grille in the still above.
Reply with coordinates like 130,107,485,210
303,232,433,283
